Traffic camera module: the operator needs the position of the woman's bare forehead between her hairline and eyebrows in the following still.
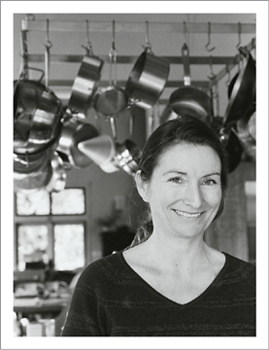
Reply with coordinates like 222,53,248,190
155,143,221,173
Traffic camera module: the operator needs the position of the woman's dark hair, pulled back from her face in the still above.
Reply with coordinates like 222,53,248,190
129,115,228,246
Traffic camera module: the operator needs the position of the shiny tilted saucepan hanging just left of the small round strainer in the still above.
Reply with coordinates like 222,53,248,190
68,55,104,114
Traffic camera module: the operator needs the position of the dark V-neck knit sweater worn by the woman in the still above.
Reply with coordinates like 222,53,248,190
62,252,256,336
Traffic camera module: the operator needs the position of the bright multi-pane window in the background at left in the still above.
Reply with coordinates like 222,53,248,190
15,188,86,271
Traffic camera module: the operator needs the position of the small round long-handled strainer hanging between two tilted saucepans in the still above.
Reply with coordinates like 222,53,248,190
93,21,129,117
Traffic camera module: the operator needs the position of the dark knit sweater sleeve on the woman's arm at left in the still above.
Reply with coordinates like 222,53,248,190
61,265,102,336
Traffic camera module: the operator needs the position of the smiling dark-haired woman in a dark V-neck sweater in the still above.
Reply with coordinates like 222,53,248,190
62,116,255,336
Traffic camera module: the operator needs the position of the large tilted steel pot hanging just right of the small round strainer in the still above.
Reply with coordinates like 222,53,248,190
125,47,170,109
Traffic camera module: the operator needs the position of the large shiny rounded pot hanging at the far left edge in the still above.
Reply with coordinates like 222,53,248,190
13,80,62,154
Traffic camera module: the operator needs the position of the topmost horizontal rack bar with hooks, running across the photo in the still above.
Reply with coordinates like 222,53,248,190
21,19,253,35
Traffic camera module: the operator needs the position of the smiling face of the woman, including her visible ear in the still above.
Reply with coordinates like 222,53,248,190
138,143,222,241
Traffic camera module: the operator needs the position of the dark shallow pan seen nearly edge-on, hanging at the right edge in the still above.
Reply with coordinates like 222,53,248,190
224,47,256,125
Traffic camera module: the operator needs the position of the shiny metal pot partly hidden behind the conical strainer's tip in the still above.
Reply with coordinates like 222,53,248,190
56,116,99,168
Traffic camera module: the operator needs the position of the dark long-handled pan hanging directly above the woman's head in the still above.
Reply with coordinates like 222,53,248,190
169,43,212,124
